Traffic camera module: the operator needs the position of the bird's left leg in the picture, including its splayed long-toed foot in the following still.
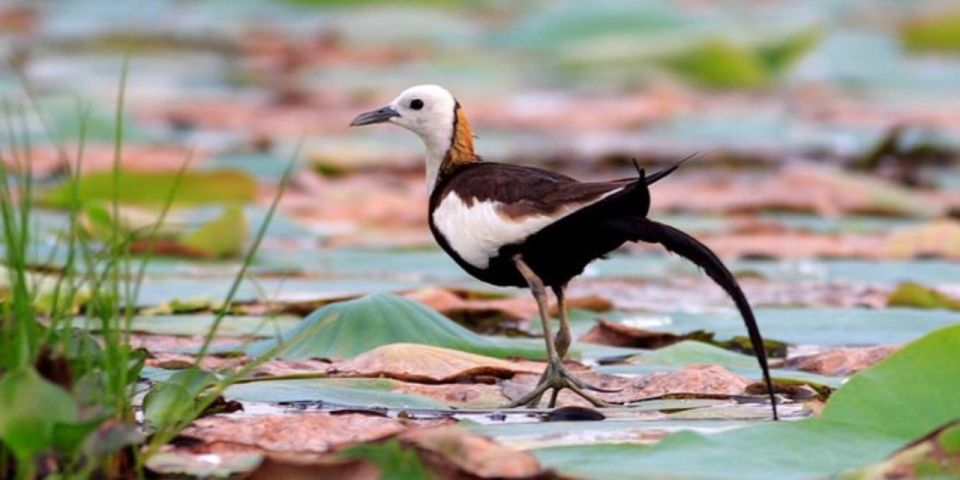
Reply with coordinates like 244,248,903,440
507,255,609,408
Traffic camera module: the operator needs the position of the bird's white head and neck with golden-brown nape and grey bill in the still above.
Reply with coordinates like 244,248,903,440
350,85,473,191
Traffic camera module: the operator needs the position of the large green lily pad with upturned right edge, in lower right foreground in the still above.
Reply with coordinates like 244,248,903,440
537,325,960,479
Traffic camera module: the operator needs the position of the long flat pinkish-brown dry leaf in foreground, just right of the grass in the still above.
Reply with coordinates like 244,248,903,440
182,413,452,453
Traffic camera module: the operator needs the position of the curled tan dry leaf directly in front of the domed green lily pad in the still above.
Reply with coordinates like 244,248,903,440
330,343,542,383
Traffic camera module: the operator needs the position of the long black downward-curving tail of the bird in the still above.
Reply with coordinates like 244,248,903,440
612,217,779,420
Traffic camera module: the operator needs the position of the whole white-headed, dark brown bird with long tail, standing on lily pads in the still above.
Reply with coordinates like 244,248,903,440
350,85,778,420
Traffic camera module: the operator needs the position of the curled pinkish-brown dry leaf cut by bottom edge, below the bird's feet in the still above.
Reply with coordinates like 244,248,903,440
398,426,547,479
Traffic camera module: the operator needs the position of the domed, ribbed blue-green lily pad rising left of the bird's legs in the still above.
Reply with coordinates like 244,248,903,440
246,294,545,359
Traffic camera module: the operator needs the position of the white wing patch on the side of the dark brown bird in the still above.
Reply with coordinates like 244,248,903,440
433,189,620,268
